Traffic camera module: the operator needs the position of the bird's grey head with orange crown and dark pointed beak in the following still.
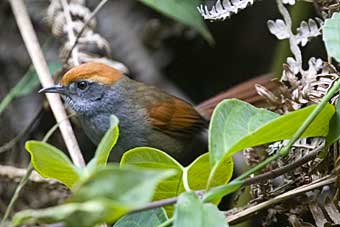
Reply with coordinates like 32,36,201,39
40,62,123,114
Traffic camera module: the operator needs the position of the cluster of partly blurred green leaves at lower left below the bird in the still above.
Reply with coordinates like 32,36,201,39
13,116,173,227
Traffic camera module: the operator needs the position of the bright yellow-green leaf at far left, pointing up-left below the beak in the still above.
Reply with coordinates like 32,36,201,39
25,140,80,188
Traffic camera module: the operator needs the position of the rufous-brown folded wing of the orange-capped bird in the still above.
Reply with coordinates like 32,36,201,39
147,96,207,139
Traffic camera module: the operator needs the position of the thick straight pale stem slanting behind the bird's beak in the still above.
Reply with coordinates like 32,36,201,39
9,0,85,167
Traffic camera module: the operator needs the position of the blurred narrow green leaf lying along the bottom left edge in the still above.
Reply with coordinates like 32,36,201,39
13,199,131,227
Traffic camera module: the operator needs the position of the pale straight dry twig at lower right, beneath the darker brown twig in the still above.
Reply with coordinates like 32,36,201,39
226,176,336,224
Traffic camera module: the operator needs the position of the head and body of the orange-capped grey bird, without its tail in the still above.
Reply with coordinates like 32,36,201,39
41,62,207,161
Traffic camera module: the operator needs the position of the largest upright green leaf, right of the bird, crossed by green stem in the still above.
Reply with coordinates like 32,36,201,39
209,99,334,165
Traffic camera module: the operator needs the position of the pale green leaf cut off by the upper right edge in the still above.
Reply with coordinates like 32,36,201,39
322,13,340,62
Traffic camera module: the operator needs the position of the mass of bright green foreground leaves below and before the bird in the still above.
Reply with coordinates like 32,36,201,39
13,99,334,227
